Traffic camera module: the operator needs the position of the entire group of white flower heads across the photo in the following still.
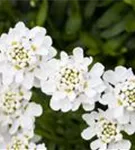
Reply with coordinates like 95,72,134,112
0,22,135,150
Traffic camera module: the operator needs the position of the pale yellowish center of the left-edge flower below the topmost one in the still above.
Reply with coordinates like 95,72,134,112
2,91,22,114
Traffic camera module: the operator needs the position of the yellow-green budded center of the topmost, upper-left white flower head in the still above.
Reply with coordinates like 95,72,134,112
8,42,31,70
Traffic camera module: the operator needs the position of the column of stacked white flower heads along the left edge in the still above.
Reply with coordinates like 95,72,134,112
0,22,53,150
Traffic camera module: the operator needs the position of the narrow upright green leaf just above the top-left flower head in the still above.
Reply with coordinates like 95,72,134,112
36,0,48,26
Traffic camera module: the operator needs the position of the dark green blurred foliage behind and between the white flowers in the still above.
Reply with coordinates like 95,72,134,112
0,0,135,150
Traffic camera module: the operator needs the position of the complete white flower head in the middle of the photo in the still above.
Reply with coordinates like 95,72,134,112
39,48,105,112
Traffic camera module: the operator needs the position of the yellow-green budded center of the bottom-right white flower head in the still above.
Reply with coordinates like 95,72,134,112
97,119,118,143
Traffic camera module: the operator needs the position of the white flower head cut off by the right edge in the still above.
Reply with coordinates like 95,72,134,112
101,66,135,134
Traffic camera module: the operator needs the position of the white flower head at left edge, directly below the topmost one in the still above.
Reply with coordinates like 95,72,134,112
0,84,42,134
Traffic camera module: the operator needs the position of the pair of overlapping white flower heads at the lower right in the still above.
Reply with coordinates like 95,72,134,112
81,66,135,150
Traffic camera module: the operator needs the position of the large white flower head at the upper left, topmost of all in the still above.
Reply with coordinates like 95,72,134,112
0,22,56,89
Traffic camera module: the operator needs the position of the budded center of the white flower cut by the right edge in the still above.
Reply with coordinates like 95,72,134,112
116,80,135,111
